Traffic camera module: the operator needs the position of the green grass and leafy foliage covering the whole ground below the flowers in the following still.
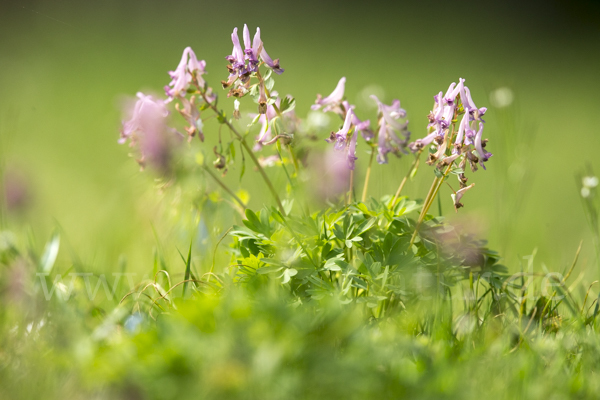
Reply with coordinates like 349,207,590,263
0,203,600,400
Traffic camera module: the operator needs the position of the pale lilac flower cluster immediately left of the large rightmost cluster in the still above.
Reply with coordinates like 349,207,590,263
371,95,410,164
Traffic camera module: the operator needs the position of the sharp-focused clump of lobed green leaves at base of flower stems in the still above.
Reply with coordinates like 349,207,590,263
231,198,506,317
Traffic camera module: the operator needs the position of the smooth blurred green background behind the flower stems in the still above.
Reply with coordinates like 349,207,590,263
0,0,600,273
